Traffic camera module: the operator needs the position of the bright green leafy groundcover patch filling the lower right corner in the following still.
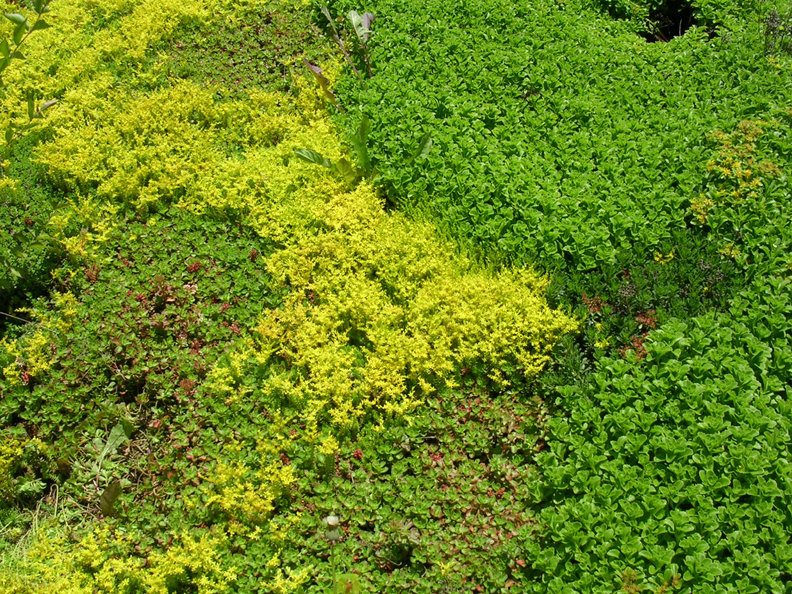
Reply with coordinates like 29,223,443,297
533,278,792,593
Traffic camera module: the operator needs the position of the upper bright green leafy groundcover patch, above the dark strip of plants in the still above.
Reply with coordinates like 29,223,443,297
331,0,790,270
